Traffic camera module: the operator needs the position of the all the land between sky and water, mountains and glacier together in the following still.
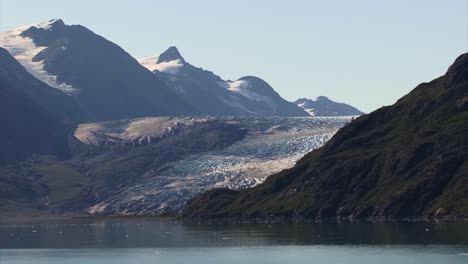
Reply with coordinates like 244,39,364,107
5,19,462,220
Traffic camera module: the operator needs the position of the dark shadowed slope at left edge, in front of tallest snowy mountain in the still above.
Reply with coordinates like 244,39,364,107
0,48,79,164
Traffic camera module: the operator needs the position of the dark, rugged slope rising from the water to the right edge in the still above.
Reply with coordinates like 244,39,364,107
183,54,468,219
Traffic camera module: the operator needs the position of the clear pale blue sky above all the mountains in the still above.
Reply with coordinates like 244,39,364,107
0,0,468,111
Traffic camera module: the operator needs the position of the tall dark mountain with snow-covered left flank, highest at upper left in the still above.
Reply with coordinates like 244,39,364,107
0,19,200,121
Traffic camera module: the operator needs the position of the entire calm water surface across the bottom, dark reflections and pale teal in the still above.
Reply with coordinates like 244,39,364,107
0,219,468,264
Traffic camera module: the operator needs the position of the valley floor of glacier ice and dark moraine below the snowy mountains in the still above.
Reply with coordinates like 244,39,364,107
0,117,353,216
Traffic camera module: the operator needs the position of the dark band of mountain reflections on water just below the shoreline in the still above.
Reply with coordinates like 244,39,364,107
0,219,468,248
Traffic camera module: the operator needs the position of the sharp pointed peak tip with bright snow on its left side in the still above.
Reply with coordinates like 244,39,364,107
138,47,185,74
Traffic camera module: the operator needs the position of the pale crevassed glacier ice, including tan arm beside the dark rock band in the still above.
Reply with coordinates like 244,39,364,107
77,117,351,215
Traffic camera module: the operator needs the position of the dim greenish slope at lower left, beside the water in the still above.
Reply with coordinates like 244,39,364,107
0,156,90,215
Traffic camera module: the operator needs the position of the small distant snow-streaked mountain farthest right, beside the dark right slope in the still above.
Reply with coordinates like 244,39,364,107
294,96,364,116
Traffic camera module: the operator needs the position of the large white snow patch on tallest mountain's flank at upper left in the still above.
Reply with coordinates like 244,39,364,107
0,19,77,94
